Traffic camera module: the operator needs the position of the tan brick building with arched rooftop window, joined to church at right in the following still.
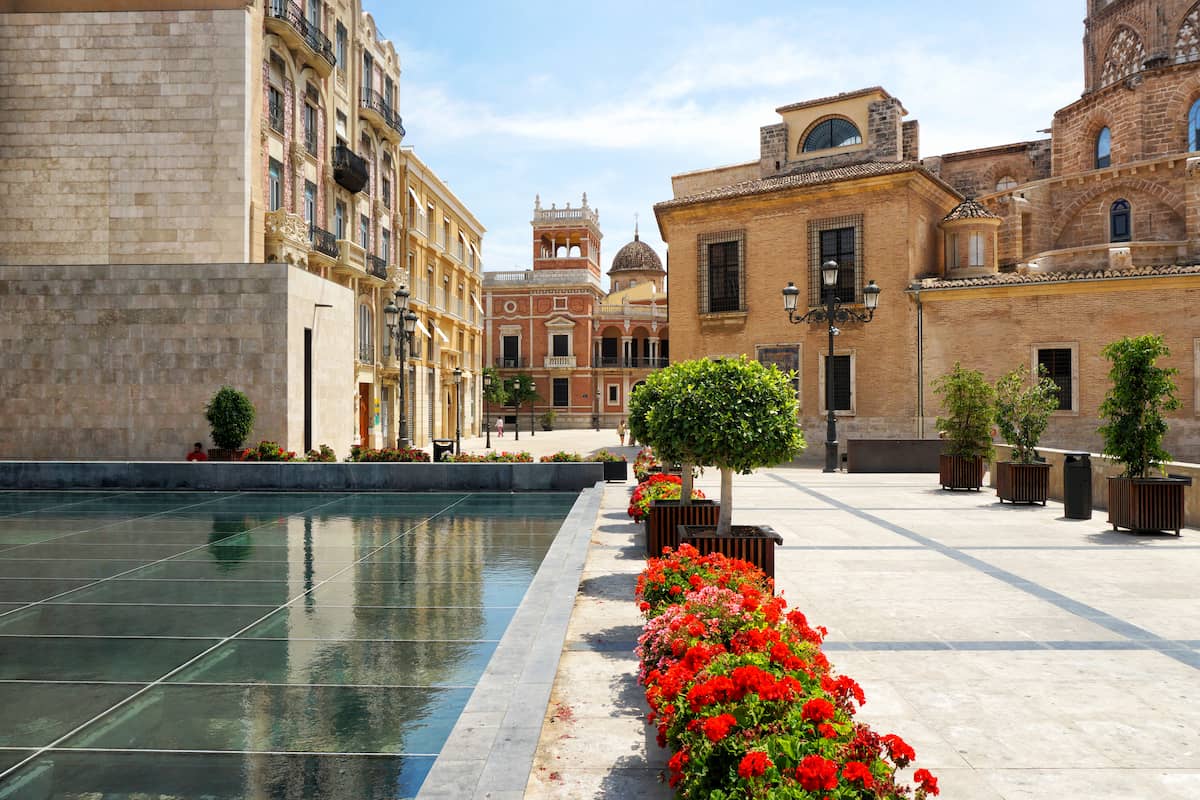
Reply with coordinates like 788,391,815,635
655,0,1200,461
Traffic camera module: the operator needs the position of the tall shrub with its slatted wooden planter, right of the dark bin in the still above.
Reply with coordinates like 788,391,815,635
1099,333,1188,535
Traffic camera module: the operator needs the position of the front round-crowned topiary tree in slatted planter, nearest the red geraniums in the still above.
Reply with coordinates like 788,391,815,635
650,356,804,577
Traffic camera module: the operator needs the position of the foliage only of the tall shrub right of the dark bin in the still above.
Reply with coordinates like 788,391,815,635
1099,333,1180,477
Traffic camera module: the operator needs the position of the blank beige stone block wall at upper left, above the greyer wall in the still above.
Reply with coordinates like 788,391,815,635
0,10,249,264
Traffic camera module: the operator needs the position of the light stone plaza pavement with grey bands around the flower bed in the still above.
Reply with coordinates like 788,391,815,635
511,453,1200,800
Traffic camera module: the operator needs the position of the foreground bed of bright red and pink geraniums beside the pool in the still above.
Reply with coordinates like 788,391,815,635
637,545,938,800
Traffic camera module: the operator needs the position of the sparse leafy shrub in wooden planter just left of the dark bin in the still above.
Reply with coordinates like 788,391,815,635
996,365,1058,505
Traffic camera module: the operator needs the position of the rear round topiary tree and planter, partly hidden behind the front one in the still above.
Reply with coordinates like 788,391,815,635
629,362,720,558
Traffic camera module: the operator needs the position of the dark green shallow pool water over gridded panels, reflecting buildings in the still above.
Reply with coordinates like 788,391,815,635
0,492,575,800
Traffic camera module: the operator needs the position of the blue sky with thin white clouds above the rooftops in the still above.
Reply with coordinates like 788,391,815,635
366,0,1086,281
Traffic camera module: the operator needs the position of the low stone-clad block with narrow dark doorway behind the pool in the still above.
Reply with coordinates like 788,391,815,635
0,264,354,459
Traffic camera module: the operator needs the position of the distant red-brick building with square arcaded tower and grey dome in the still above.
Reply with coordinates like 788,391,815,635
484,194,671,429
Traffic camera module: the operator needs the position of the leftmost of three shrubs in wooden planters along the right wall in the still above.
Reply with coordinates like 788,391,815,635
934,361,996,492
